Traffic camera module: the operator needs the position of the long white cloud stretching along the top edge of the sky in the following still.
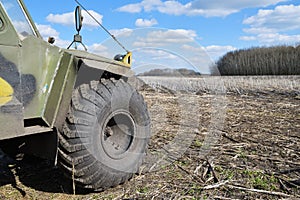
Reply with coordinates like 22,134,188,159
117,0,288,17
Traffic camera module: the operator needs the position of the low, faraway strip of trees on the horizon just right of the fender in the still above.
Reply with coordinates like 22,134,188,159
139,68,201,76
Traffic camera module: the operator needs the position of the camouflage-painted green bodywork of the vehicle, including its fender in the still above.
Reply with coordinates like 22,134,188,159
0,0,133,140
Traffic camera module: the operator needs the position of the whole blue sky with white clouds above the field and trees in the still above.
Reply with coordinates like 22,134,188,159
24,0,300,73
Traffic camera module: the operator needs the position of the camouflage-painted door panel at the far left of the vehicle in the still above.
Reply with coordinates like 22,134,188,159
0,1,24,138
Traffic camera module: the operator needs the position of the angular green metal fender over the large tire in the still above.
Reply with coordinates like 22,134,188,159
43,49,134,129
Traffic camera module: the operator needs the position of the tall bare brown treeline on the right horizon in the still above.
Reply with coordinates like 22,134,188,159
211,45,300,75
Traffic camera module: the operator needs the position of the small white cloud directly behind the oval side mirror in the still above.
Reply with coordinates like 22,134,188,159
46,10,103,27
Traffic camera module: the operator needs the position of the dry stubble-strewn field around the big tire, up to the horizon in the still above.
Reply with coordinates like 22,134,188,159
0,76,300,200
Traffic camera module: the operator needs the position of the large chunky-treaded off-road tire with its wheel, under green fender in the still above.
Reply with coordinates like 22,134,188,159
58,79,150,190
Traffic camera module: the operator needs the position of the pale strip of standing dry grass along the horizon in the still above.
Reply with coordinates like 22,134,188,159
139,76,300,94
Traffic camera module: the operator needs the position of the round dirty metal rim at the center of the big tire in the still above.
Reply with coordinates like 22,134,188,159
100,111,136,159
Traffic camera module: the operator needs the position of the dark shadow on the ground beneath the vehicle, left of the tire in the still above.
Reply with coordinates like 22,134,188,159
0,149,88,197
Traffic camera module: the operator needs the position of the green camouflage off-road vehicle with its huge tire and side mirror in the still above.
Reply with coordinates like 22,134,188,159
0,0,150,190
